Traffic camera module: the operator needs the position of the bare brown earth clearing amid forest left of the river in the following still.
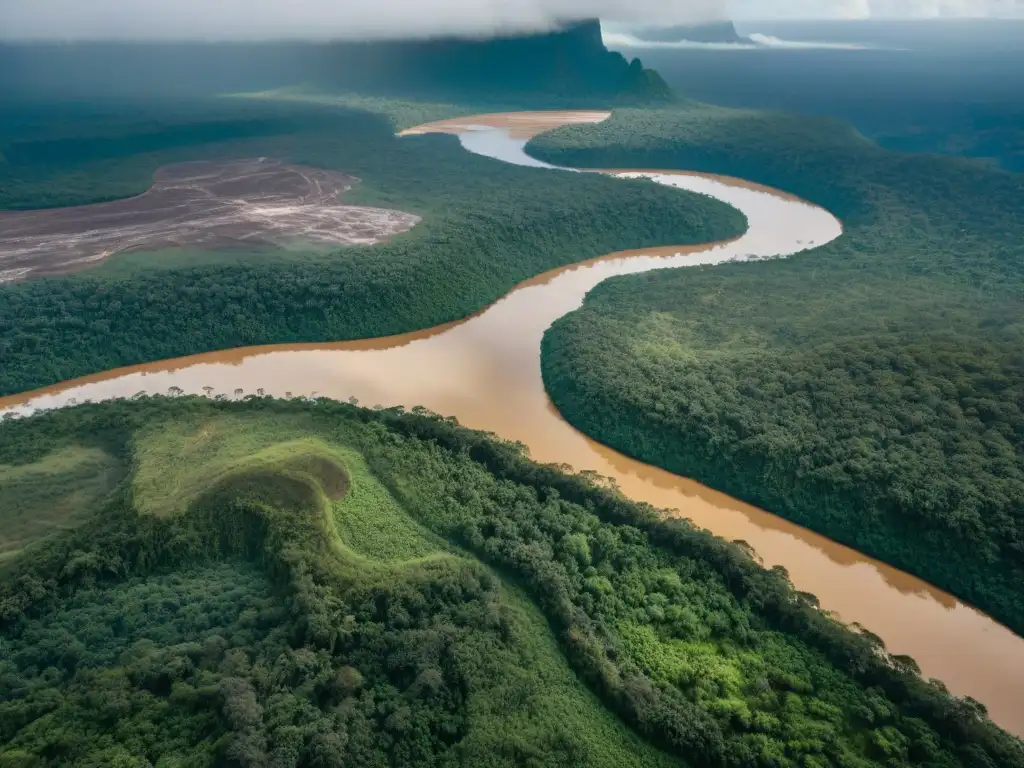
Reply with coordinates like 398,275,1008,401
0,158,420,283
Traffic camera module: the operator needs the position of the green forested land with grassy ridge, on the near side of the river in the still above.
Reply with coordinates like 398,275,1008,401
0,397,1024,768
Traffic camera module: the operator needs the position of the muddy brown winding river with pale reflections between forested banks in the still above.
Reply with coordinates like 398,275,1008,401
0,113,1024,734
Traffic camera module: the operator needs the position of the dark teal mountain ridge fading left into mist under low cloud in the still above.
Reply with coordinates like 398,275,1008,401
0,20,672,105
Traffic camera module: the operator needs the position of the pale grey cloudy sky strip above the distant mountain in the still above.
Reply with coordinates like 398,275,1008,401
0,0,1024,40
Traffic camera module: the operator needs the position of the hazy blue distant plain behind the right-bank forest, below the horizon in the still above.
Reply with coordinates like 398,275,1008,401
644,49,1024,172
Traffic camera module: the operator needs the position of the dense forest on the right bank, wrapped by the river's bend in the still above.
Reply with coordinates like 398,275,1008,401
531,104,1024,632
